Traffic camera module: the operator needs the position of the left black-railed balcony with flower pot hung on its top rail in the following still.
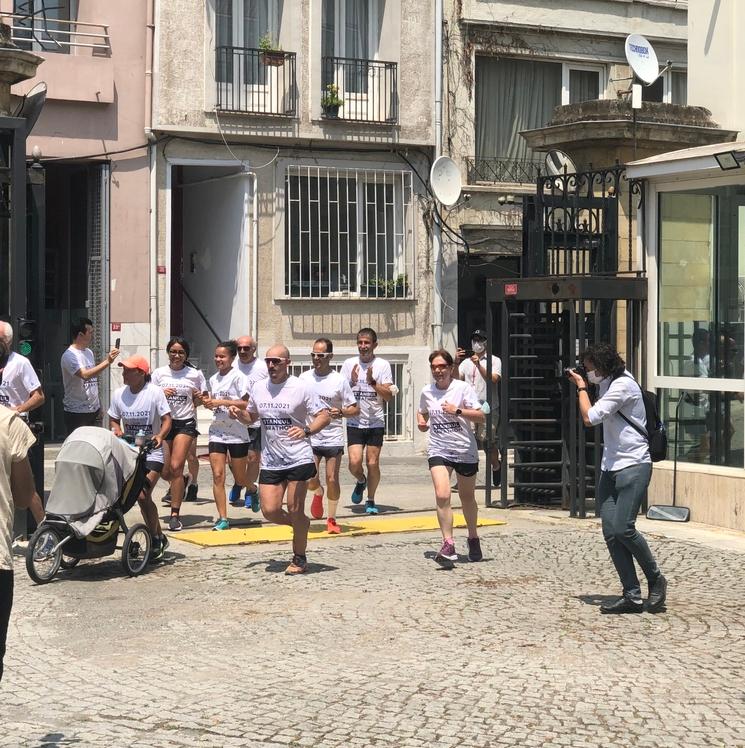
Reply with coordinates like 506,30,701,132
215,47,297,117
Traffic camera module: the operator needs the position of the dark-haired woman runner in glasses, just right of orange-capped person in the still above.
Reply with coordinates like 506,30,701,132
153,337,207,532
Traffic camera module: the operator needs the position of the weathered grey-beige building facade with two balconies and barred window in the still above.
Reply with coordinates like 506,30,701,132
151,0,435,447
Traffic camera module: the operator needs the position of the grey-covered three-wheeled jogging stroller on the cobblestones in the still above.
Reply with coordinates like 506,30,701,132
26,426,152,584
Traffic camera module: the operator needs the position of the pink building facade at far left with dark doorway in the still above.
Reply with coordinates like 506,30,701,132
0,0,152,440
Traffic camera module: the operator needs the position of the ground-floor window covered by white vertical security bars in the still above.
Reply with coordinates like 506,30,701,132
284,166,413,298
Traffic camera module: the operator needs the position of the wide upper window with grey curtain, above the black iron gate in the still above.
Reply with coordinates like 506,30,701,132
476,56,605,163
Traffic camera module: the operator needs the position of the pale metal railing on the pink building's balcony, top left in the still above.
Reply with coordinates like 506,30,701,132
0,13,111,56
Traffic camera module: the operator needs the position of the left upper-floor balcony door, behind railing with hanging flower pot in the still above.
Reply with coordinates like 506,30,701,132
215,0,289,114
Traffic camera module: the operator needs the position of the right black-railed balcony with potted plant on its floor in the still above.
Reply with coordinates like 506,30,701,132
321,57,398,125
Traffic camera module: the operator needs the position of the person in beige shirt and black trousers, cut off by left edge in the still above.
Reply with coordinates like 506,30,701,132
0,407,36,681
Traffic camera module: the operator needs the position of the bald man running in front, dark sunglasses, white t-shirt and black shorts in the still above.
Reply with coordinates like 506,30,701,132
241,345,331,574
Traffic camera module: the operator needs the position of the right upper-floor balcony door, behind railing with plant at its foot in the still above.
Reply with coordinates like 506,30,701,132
323,0,393,121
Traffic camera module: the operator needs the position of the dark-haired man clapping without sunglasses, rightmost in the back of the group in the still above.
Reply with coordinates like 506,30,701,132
341,327,394,514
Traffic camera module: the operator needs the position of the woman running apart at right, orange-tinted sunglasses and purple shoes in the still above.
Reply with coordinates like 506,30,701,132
417,349,485,569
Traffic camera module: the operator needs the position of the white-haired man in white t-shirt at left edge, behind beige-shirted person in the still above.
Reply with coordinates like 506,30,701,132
0,322,46,523
